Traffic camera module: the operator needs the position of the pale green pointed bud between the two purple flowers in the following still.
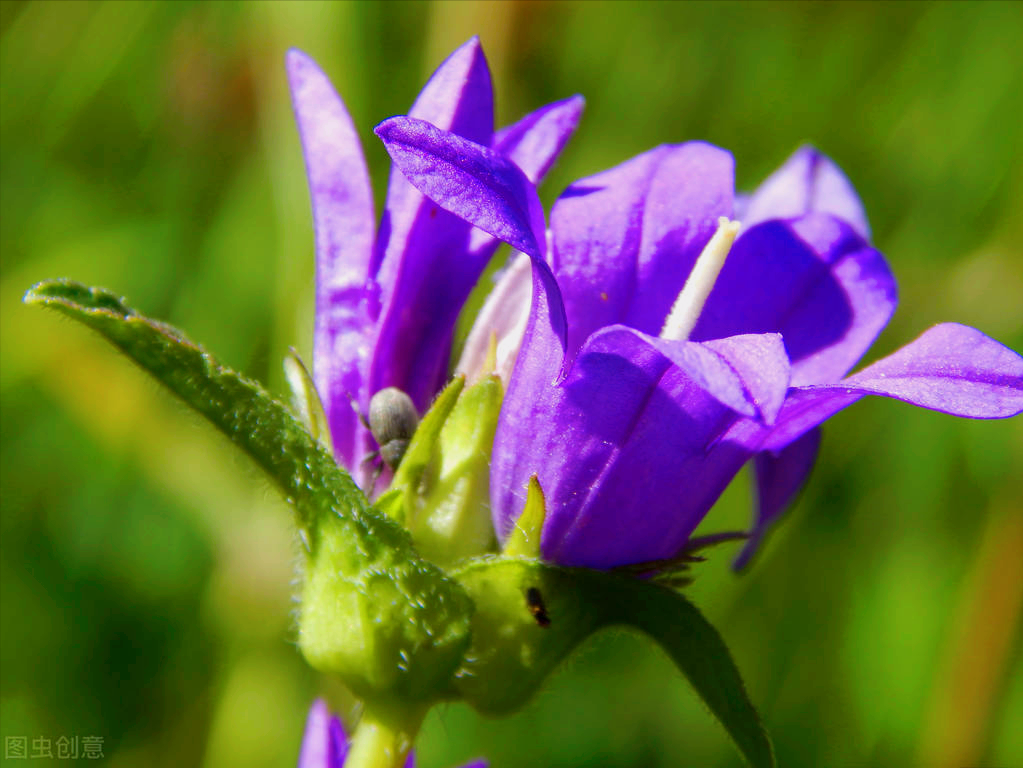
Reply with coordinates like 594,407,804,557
388,375,503,567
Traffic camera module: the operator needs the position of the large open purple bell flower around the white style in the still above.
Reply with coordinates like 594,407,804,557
376,118,1023,568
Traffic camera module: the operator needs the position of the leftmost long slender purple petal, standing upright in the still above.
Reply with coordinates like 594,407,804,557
286,49,380,467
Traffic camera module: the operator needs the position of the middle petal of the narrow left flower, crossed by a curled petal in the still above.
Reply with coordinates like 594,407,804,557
369,38,493,410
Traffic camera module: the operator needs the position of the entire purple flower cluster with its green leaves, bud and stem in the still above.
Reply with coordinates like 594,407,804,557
25,31,1023,768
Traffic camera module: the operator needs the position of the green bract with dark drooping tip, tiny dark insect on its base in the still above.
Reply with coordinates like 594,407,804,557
452,556,774,768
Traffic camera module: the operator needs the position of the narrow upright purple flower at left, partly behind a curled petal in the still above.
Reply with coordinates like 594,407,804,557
286,38,583,477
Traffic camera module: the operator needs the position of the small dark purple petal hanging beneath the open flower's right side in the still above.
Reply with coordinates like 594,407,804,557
732,430,820,571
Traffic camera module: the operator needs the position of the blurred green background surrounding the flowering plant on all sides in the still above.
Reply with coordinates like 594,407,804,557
0,1,1023,768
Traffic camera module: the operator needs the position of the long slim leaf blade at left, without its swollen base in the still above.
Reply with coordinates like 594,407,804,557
25,280,394,544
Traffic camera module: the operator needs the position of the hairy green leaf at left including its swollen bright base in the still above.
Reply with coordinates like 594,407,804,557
25,281,473,711
